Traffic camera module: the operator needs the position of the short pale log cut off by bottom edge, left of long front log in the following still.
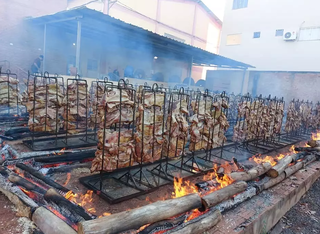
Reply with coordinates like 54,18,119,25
32,207,77,234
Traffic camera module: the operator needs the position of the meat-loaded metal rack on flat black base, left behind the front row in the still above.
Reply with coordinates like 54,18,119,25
23,73,97,151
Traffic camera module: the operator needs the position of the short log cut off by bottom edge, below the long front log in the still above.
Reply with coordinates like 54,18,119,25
166,209,222,234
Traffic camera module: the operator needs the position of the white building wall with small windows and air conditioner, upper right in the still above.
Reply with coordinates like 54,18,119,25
220,0,320,71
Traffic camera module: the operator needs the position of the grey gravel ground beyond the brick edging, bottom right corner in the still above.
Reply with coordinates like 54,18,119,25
280,179,320,234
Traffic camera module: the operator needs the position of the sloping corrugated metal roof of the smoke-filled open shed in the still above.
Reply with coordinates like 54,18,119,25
26,7,253,69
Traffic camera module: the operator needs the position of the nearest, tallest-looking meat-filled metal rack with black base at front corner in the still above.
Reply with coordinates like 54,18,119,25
80,80,156,203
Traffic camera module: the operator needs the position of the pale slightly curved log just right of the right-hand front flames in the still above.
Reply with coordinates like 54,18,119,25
228,162,272,181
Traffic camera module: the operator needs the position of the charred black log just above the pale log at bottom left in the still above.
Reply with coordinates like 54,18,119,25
44,188,93,220
